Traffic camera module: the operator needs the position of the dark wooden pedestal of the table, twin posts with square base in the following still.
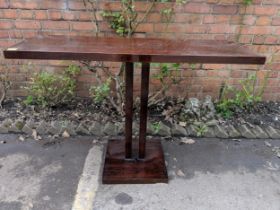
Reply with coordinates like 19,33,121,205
102,63,168,184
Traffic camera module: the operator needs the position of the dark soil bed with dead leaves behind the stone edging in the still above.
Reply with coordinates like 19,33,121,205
0,98,280,129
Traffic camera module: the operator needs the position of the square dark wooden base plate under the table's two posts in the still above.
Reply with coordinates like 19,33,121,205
102,140,168,184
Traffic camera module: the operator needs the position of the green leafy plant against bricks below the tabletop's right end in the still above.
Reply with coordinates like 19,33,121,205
216,72,269,118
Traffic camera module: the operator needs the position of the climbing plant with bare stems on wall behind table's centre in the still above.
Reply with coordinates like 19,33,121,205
81,0,189,115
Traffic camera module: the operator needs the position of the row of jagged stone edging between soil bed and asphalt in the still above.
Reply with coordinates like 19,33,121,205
0,119,280,139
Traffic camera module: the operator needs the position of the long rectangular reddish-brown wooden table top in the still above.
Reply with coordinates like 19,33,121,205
4,36,266,64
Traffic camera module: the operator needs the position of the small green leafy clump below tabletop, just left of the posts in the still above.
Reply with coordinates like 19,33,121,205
90,78,112,103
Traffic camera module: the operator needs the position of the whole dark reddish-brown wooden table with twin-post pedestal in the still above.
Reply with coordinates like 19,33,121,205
4,36,266,184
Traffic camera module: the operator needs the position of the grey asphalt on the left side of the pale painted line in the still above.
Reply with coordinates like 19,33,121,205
0,135,92,210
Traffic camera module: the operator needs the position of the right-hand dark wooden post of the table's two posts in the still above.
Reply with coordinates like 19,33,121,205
139,63,150,159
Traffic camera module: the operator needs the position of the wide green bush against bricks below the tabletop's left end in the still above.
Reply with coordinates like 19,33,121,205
24,65,80,107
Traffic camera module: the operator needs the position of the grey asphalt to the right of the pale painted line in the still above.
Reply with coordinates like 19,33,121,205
93,139,280,210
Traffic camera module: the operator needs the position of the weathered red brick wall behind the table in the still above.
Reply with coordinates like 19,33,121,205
0,0,280,100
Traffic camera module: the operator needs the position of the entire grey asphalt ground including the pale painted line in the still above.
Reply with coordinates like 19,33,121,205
0,135,280,210
